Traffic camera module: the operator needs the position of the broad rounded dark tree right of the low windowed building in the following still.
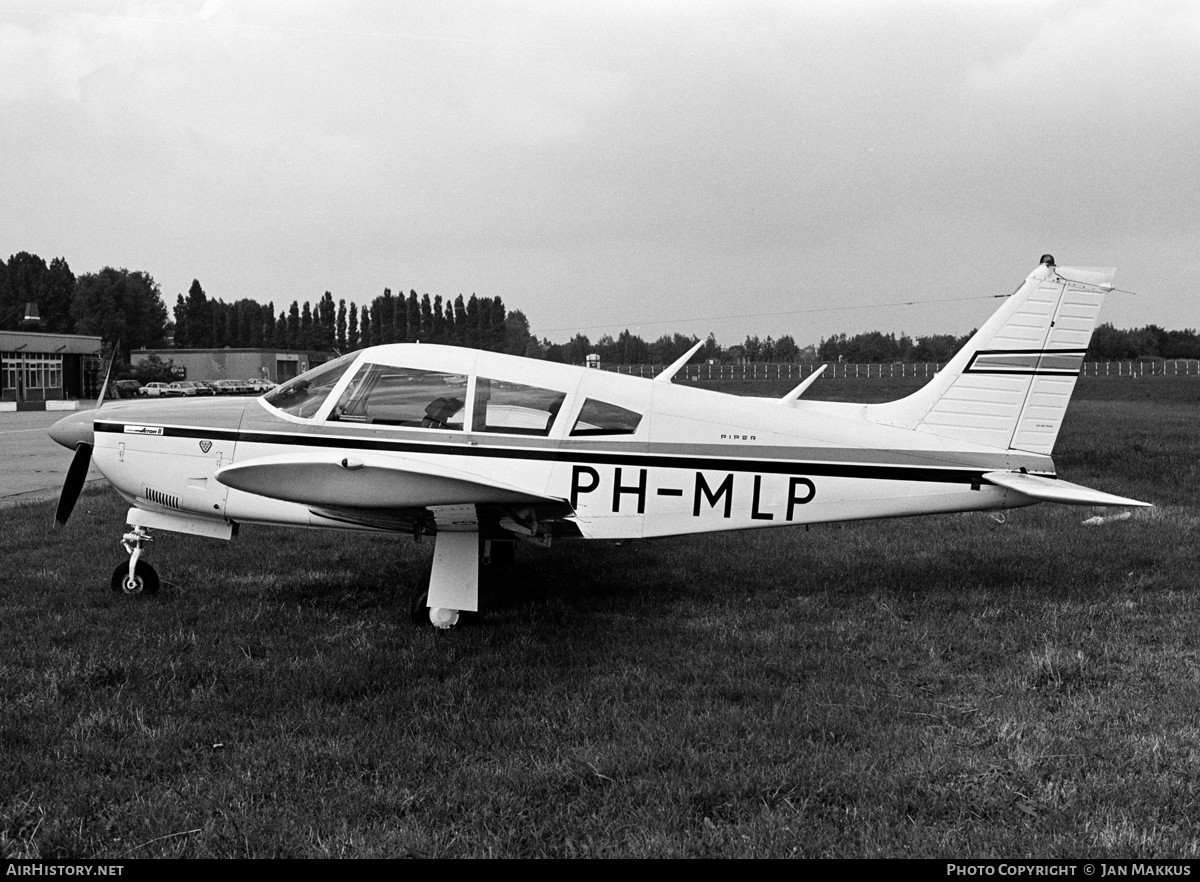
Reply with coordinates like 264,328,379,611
71,266,167,361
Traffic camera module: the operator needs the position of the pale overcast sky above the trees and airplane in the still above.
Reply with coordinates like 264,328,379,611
0,0,1200,346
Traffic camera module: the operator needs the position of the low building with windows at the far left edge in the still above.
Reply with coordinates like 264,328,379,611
0,331,103,409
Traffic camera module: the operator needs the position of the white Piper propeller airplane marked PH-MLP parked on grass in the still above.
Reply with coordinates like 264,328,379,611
50,254,1148,629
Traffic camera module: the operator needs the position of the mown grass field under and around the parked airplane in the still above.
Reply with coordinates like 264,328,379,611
0,377,1200,858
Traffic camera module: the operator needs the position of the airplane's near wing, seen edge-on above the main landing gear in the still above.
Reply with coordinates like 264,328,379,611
216,452,565,510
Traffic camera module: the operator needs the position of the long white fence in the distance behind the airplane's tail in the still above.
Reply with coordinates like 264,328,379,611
600,359,1200,383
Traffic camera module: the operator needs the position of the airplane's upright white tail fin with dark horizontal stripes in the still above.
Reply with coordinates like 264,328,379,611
868,254,1116,454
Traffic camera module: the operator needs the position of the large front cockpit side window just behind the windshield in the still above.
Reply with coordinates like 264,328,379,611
329,365,467,430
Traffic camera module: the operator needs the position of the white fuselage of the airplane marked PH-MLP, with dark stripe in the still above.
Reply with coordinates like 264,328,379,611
84,344,1054,539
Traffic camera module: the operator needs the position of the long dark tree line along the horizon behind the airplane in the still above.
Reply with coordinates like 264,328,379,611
0,252,1200,365
